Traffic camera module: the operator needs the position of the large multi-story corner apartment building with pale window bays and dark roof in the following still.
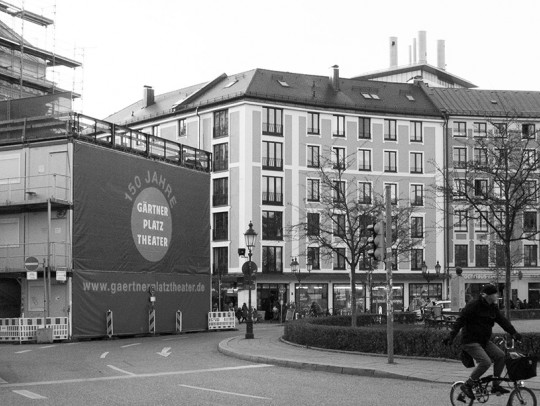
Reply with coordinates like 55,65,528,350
107,66,445,313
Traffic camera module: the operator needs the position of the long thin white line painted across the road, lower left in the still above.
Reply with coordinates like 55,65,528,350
2,364,274,388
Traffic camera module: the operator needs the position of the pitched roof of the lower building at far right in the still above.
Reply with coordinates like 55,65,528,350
422,86,540,118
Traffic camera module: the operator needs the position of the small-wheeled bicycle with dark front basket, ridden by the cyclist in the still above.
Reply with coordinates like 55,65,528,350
450,337,537,406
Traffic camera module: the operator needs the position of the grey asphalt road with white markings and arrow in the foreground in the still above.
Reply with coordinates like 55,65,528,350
0,325,524,406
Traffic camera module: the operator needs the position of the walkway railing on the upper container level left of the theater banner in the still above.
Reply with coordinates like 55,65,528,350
0,173,71,205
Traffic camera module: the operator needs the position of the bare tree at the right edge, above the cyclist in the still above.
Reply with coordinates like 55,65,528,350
439,114,540,317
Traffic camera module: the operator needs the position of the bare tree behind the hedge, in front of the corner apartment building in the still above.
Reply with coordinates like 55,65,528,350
288,151,415,327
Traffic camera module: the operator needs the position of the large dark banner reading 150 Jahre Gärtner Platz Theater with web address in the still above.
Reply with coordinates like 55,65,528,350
73,141,211,337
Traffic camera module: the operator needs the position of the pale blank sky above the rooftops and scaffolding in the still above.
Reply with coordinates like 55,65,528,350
4,0,540,118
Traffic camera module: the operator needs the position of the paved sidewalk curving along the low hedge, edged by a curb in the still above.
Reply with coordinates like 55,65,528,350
218,324,540,391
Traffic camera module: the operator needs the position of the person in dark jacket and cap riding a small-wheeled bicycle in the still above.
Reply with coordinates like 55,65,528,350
443,284,521,399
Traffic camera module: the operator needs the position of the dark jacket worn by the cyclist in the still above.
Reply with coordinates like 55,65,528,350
450,297,516,346
